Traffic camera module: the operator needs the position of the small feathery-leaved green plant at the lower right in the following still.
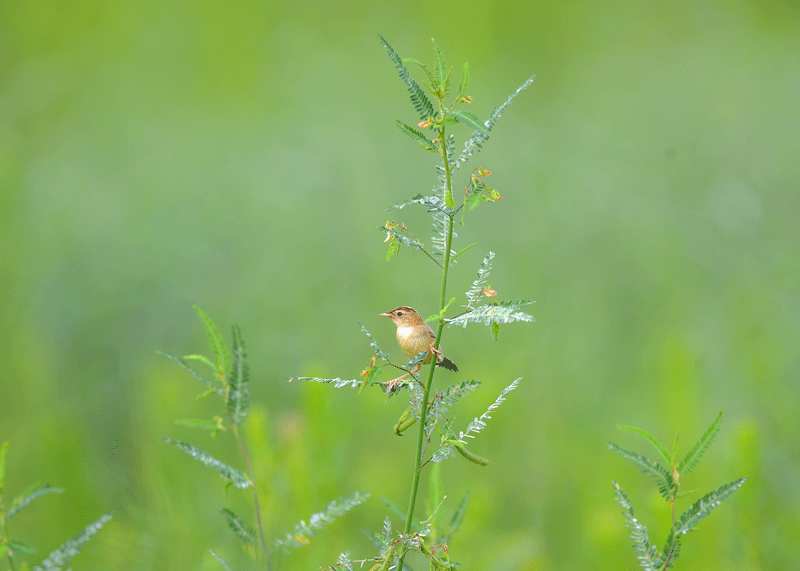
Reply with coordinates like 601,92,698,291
608,411,746,571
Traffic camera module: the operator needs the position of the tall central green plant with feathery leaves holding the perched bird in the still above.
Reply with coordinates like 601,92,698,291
288,36,533,571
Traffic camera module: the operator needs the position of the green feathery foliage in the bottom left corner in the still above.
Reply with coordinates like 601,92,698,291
0,441,111,571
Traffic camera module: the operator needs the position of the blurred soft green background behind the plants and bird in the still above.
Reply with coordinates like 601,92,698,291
0,0,800,571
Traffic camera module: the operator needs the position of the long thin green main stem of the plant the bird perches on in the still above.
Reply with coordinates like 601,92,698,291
397,127,453,571
